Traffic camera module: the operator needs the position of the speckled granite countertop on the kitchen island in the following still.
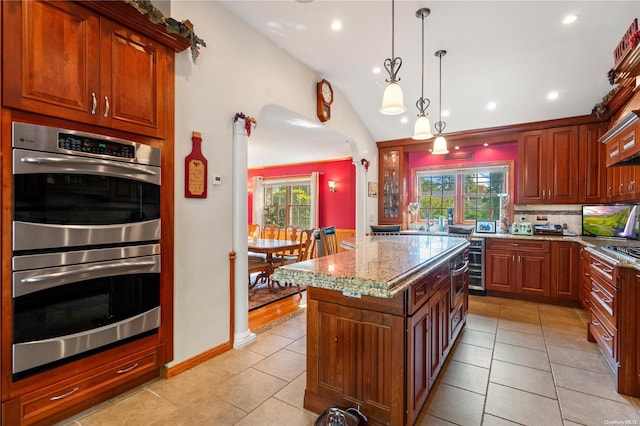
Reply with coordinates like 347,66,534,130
272,235,469,298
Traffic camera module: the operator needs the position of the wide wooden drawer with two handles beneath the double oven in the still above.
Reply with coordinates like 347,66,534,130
20,348,159,424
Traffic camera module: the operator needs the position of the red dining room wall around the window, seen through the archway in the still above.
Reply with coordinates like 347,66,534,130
247,159,356,229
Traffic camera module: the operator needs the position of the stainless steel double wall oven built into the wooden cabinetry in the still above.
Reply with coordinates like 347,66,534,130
12,122,160,379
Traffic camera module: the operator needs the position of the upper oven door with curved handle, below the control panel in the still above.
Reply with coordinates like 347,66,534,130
13,149,160,251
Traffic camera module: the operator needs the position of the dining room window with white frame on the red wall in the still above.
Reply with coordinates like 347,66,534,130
262,179,311,229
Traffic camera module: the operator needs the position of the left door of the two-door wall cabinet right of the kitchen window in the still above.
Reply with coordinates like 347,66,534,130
518,130,547,204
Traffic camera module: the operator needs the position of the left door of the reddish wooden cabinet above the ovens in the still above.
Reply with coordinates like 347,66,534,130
2,1,100,124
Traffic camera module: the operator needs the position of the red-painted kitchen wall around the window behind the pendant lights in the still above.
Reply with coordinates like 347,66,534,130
407,141,518,200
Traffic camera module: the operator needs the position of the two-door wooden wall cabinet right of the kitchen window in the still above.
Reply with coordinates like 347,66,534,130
518,126,579,204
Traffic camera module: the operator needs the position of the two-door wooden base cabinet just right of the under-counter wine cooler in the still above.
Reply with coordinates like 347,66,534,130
485,238,551,296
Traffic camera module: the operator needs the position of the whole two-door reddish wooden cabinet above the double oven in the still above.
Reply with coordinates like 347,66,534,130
2,1,173,139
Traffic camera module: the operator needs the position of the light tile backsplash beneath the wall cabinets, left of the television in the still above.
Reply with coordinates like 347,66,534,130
513,204,582,235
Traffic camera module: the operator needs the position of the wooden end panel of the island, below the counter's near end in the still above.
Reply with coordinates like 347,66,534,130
305,288,405,425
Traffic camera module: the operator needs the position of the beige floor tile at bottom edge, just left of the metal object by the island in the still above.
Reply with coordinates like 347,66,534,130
236,398,318,426
